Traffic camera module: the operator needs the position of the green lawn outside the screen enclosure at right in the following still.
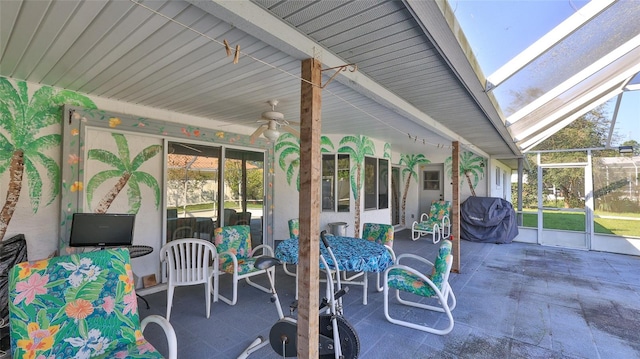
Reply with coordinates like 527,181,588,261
523,211,640,237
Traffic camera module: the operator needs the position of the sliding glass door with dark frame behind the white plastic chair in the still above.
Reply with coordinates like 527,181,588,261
166,142,265,245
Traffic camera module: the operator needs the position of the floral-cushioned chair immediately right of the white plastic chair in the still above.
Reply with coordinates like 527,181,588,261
213,226,275,305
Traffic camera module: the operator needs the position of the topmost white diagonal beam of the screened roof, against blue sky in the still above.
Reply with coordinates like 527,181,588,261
485,0,617,91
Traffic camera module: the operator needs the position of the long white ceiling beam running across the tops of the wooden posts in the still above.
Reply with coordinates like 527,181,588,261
187,0,470,148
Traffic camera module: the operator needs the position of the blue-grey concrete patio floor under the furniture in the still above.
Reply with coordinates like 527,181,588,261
139,230,640,359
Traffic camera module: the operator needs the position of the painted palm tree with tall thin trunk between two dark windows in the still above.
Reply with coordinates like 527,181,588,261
338,136,375,237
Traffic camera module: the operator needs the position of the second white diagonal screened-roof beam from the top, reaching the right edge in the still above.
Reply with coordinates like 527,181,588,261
507,35,640,126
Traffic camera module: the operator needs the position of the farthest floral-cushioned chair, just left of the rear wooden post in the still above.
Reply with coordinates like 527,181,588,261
411,201,451,244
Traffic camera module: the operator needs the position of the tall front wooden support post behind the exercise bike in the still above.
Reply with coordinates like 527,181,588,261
298,59,322,359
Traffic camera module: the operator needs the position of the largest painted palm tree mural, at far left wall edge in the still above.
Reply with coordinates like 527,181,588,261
0,77,96,240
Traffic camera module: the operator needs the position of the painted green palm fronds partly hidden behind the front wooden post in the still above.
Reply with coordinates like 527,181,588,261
275,132,333,191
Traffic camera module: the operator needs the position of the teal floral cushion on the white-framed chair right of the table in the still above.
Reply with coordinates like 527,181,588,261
387,240,452,297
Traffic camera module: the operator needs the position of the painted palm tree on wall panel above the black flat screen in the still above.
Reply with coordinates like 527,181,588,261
86,133,162,213
